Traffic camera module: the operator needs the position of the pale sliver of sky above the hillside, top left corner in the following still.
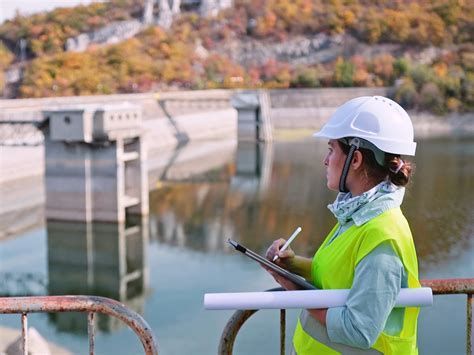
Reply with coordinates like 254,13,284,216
0,0,103,23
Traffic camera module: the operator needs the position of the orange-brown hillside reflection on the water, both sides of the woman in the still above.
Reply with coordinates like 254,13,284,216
150,137,474,271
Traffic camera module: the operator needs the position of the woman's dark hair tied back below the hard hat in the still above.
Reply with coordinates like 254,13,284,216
338,141,414,186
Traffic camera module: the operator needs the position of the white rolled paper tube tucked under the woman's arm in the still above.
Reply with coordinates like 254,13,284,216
204,287,433,310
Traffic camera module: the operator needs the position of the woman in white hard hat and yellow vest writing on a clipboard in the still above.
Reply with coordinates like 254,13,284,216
266,96,420,355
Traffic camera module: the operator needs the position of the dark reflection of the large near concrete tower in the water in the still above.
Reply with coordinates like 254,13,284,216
47,219,148,332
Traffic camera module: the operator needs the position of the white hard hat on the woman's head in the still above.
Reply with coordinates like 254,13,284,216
313,96,416,155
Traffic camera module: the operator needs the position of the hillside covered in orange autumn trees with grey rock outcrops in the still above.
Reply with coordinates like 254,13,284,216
0,0,474,113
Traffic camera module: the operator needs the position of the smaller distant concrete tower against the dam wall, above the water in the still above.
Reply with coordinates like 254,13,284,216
231,90,273,142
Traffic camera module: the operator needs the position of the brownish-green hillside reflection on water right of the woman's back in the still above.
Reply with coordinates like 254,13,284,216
404,137,474,272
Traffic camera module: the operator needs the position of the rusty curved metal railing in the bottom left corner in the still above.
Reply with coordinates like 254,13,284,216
0,296,158,355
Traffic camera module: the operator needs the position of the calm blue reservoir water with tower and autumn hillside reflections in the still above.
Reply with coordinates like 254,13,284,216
0,137,474,354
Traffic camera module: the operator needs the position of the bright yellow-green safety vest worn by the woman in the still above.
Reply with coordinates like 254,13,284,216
293,208,420,355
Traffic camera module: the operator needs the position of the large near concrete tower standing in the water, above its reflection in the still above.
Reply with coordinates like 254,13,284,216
44,105,149,222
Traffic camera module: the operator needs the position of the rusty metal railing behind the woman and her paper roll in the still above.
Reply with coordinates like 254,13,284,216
217,278,474,355
